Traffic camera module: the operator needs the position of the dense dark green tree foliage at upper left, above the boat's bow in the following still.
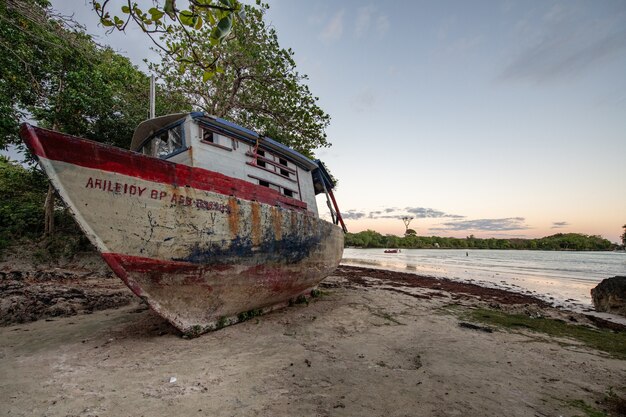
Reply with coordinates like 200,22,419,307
0,0,190,148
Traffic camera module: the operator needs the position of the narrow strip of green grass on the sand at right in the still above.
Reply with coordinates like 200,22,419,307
468,309,626,359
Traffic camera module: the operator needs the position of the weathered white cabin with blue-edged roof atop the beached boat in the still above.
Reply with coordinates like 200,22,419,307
131,112,334,216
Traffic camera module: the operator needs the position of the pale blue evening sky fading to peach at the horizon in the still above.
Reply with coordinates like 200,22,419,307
41,0,626,242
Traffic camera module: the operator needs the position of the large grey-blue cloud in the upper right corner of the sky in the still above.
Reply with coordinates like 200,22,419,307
498,9,626,83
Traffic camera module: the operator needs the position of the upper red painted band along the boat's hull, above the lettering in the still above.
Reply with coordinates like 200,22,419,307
20,123,307,211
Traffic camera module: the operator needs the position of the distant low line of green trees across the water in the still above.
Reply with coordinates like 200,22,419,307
345,230,617,251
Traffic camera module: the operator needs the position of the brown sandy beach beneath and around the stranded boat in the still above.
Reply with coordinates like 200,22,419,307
0,261,626,416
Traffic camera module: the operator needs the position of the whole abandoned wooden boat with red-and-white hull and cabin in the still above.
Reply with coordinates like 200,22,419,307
21,113,345,335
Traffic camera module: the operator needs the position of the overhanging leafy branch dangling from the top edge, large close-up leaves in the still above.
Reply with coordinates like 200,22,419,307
91,0,243,77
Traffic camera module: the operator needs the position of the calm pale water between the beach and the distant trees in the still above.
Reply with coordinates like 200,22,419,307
342,249,626,311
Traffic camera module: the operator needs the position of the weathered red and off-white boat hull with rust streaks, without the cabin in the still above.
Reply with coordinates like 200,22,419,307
22,126,343,334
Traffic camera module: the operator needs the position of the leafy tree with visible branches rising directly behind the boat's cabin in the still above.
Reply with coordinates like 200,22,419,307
151,6,330,156
